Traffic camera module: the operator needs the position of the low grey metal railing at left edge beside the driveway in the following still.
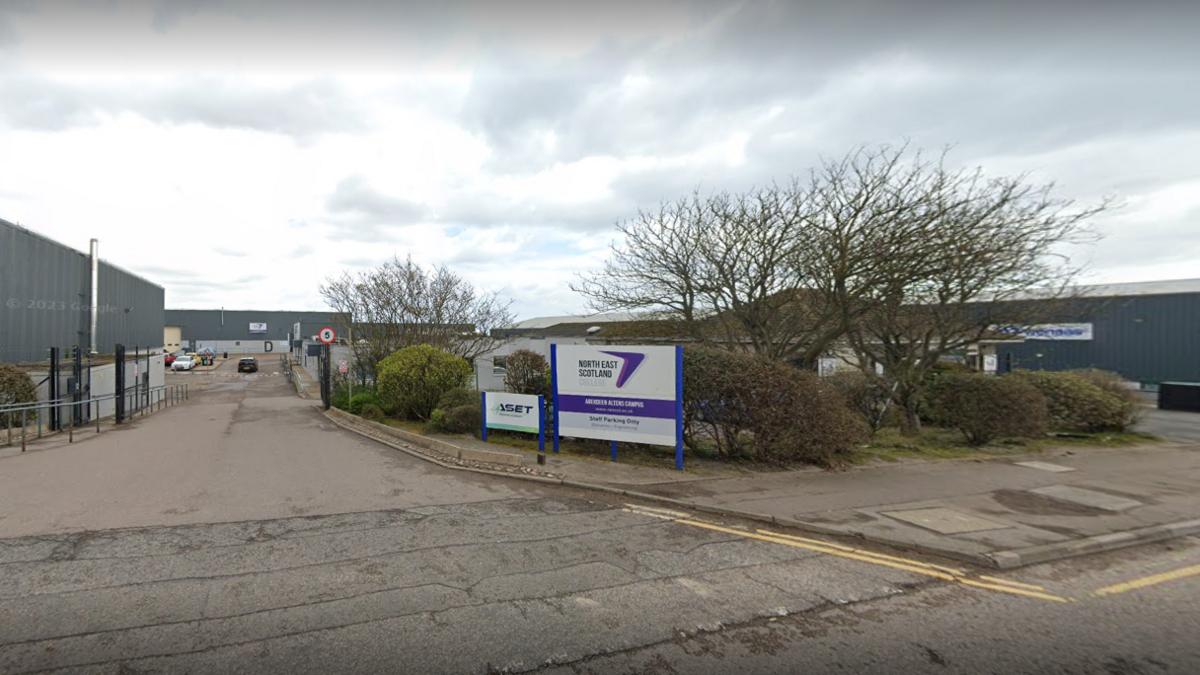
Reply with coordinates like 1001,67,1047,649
0,384,187,452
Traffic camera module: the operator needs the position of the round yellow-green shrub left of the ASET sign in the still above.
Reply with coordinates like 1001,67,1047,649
378,345,472,420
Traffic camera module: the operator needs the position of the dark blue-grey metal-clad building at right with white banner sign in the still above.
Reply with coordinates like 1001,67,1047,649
996,279,1200,383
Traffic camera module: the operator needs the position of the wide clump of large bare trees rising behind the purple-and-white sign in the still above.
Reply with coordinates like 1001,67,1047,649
572,145,1109,413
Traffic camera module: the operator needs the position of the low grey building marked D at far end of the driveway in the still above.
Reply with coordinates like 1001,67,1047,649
160,310,340,353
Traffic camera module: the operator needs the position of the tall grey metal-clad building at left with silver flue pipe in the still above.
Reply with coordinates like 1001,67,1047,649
0,220,163,363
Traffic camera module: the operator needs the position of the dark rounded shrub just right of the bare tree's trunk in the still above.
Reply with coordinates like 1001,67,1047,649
931,372,1048,446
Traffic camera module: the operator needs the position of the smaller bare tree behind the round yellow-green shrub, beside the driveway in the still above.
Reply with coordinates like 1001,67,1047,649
320,257,515,377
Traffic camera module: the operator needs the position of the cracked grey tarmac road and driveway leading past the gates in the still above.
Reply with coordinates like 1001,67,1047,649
0,358,1200,674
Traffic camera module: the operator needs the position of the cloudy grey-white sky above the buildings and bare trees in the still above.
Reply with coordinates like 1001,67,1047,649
0,0,1200,318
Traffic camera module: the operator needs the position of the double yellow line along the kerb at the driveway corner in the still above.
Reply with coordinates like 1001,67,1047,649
625,504,1075,603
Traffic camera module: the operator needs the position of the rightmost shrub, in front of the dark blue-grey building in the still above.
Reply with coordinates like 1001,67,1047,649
1006,370,1126,431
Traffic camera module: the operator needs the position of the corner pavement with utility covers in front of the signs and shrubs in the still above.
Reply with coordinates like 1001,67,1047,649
340,408,1200,569
